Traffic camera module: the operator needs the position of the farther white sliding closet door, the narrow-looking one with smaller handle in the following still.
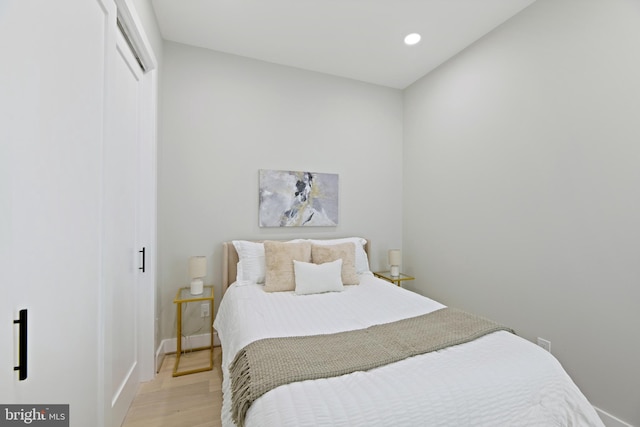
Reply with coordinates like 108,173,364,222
104,28,146,426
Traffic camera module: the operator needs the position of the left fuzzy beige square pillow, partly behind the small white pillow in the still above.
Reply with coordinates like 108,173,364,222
264,240,311,292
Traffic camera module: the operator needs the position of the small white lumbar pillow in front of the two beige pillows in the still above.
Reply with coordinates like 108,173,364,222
293,259,344,295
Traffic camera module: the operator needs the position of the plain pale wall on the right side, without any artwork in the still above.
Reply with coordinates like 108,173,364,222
403,0,640,425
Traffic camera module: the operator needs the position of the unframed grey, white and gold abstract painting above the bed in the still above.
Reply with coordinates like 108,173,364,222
258,170,338,227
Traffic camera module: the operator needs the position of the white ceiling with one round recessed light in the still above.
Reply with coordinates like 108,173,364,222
152,0,535,89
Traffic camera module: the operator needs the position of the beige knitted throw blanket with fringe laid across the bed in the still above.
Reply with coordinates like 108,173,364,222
230,308,513,426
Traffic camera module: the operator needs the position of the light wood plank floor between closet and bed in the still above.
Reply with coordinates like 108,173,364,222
122,347,222,427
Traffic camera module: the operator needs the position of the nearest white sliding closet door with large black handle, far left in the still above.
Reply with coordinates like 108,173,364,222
0,0,116,426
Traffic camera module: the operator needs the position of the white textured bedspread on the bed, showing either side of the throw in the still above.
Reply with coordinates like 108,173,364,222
214,275,603,427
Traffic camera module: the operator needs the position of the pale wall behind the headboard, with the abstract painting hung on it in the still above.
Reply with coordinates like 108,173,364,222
158,42,402,338
